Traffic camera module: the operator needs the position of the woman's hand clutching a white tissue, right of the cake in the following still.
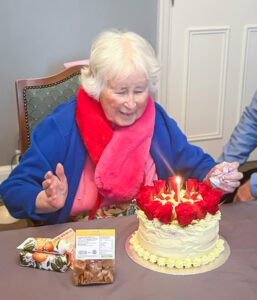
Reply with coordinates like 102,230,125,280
206,161,243,193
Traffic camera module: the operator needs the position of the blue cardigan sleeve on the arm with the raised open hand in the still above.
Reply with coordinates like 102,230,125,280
0,113,66,220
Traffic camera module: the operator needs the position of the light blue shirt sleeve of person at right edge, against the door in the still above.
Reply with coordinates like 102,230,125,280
219,91,257,164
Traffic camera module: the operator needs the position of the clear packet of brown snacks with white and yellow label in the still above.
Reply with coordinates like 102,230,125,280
73,229,115,286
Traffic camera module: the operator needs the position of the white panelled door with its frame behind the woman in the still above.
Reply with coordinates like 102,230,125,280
158,0,257,159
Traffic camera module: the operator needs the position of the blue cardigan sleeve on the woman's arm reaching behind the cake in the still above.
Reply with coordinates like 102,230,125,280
152,105,216,181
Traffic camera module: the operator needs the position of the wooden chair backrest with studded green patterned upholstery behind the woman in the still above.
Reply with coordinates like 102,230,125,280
15,65,84,154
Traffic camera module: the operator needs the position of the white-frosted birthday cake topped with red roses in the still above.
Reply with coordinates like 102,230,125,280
130,176,224,269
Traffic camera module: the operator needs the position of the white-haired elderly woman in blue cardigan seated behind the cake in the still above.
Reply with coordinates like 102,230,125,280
0,31,242,224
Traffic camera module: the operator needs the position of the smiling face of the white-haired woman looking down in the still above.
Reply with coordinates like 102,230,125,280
99,73,149,126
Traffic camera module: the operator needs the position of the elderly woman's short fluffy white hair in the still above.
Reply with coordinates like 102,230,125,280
80,30,160,100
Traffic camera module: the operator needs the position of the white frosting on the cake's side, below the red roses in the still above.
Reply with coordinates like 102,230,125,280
136,210,220,258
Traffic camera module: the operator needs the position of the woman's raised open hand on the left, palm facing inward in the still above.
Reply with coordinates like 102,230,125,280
36,163,68,213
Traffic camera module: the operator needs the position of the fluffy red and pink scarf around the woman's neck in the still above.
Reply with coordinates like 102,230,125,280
75,88,155,218
